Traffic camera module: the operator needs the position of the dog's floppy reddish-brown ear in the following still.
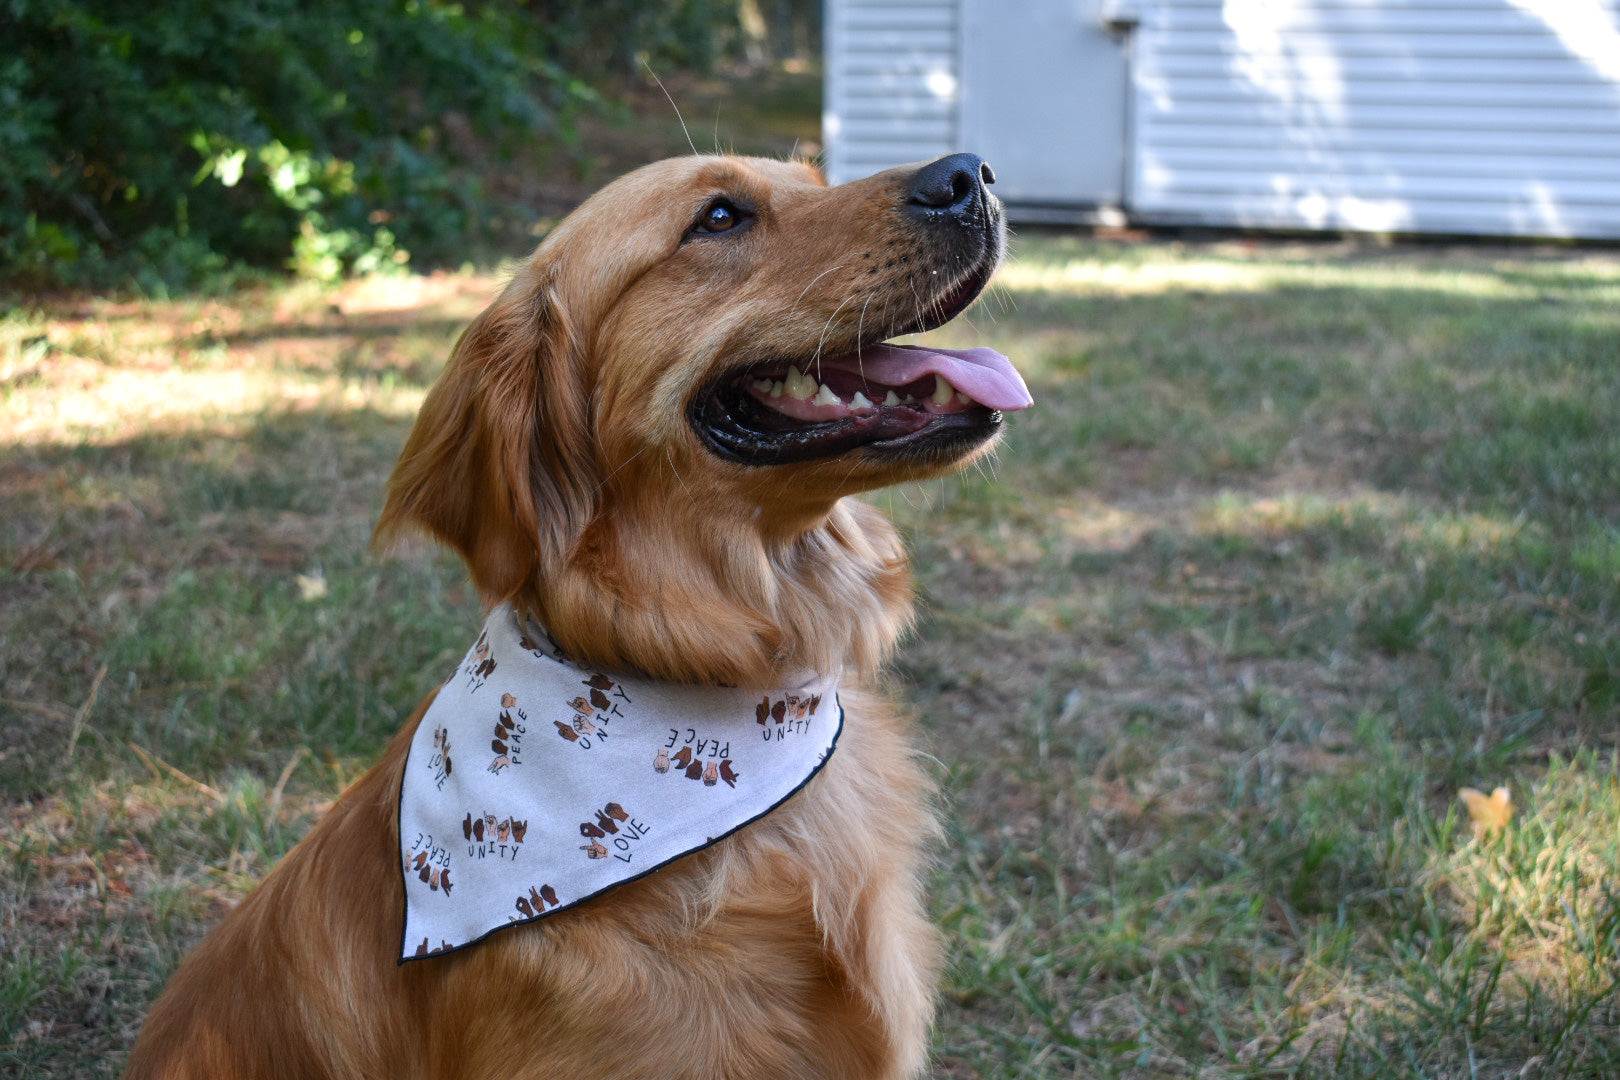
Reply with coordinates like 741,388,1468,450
373,266,595,604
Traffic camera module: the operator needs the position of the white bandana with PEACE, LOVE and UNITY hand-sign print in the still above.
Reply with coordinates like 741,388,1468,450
400,607,844,962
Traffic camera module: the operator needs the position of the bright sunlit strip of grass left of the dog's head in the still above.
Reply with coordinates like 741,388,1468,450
0,275,494,445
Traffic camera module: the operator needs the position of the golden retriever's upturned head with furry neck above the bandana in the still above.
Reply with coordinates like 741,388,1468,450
377,154,1029,682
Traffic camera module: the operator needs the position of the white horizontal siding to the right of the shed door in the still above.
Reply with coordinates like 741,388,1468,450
1129,0,1620,236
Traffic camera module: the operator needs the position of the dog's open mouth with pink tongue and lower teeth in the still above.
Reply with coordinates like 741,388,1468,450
692,272,1030,465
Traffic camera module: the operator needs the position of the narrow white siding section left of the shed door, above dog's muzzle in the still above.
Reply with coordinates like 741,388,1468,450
821,0,961,183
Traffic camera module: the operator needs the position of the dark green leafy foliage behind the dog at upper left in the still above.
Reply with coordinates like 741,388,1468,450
0,0,737,285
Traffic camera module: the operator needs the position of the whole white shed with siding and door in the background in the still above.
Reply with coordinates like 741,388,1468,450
823,0,1620,238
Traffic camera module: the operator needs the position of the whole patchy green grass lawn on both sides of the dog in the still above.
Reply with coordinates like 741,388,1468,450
0,235,1620,1080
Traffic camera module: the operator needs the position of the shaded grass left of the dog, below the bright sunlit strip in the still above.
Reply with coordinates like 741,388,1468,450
0,401,498,1077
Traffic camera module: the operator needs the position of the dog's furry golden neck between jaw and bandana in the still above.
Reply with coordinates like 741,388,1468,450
514,499,912,687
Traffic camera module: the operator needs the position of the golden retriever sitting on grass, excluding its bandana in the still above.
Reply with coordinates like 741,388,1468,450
126,154,1029,1080
